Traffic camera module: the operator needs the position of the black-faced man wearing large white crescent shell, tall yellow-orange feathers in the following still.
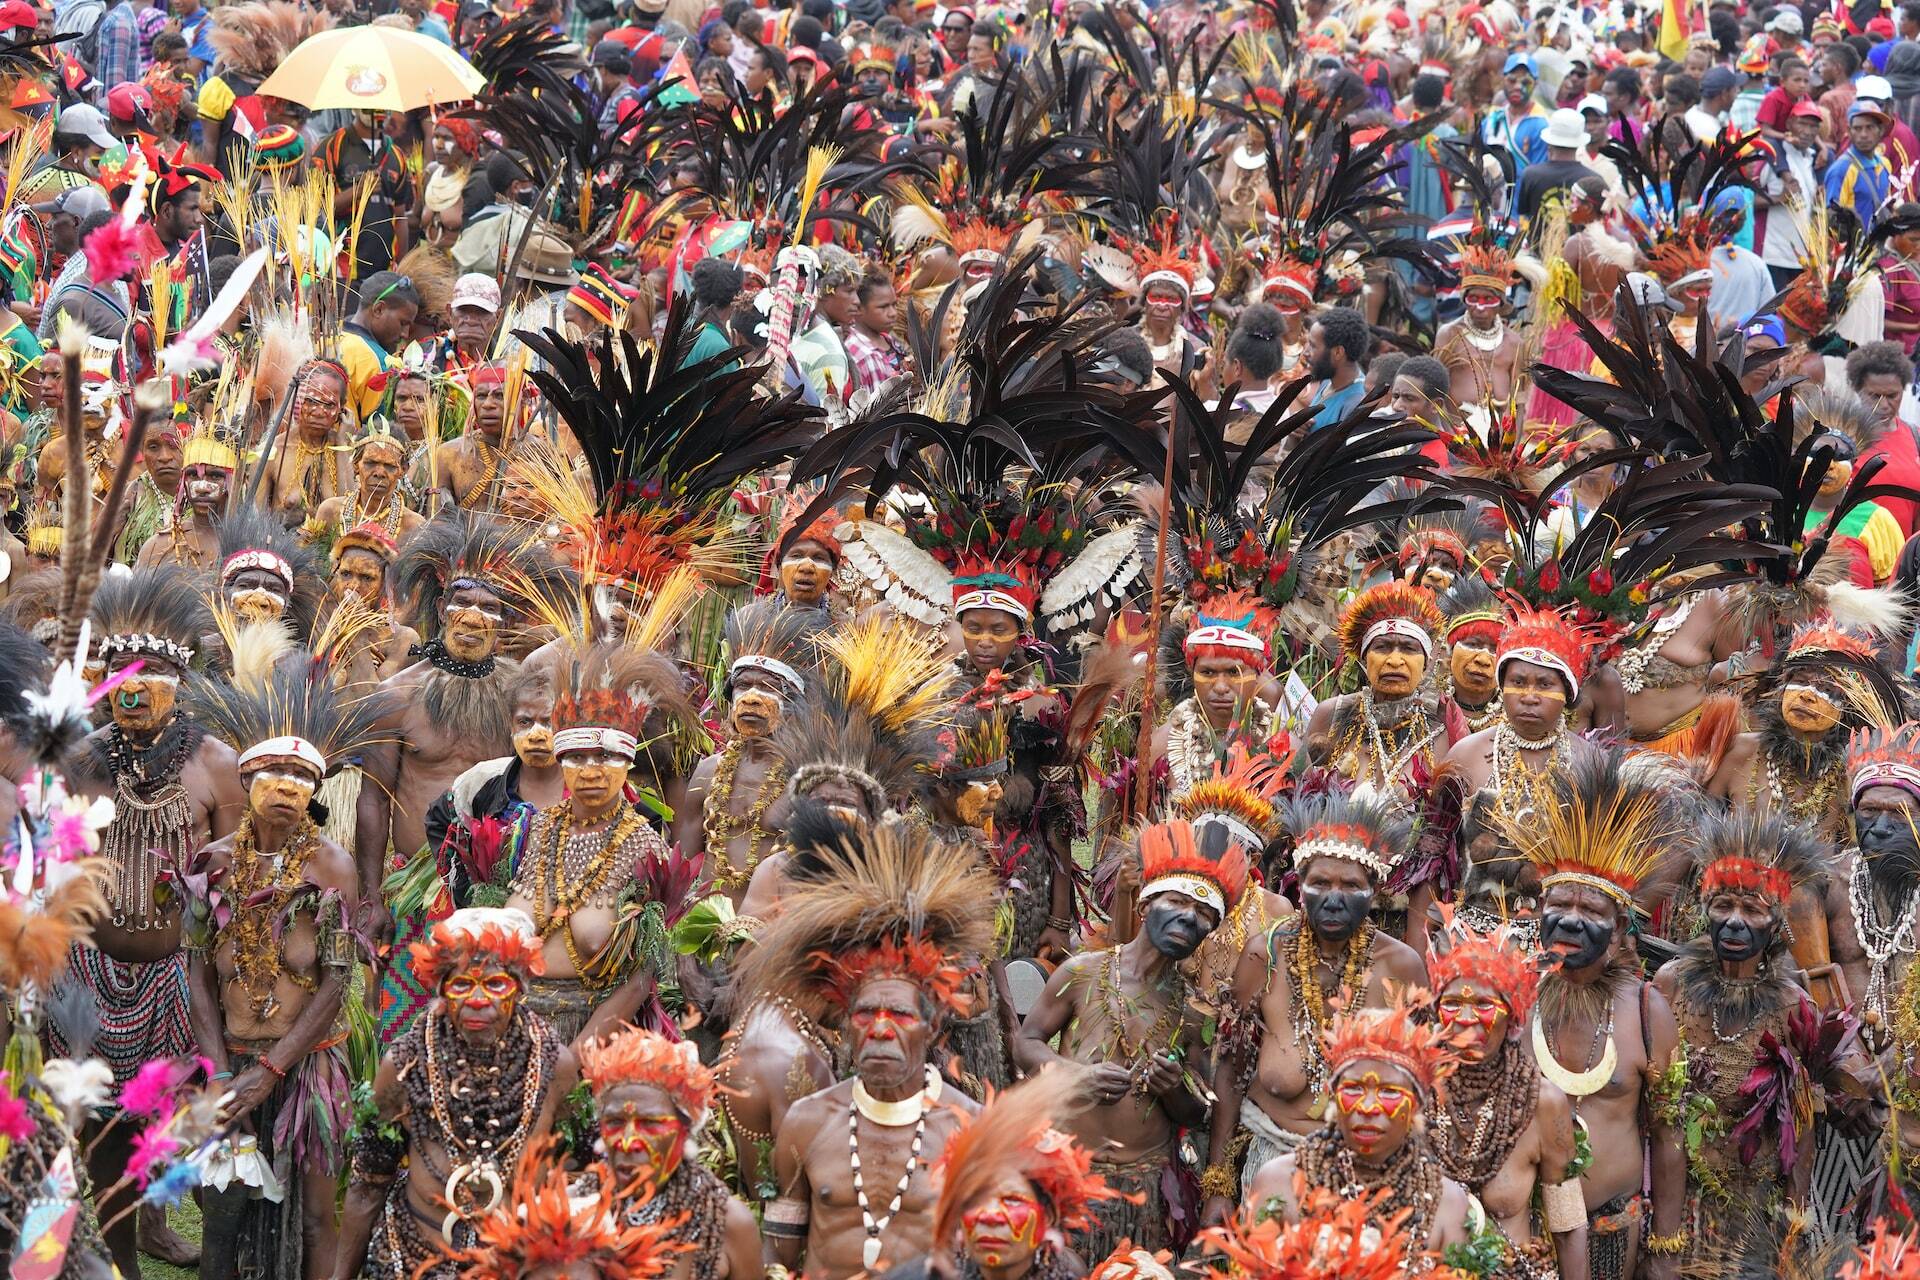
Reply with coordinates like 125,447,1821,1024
1500,750,1690,1280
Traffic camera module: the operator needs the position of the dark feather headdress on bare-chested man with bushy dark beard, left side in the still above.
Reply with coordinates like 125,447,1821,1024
388,510,572,635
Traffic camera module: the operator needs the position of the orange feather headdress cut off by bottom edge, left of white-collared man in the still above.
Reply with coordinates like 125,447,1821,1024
445,1138,693,1280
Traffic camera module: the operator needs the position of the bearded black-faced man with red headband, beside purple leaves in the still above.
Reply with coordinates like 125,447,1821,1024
1653,810,1835,1274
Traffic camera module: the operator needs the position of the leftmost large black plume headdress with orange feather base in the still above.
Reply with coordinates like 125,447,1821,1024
518,294,820,593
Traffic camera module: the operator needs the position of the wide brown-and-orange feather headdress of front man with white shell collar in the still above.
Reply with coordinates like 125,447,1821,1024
735,821,998,1021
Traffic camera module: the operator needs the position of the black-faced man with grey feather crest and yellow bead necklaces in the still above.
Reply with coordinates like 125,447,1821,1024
1202,787,1427,1221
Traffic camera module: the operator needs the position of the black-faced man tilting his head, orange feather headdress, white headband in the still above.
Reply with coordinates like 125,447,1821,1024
1014,821,1248,1259
